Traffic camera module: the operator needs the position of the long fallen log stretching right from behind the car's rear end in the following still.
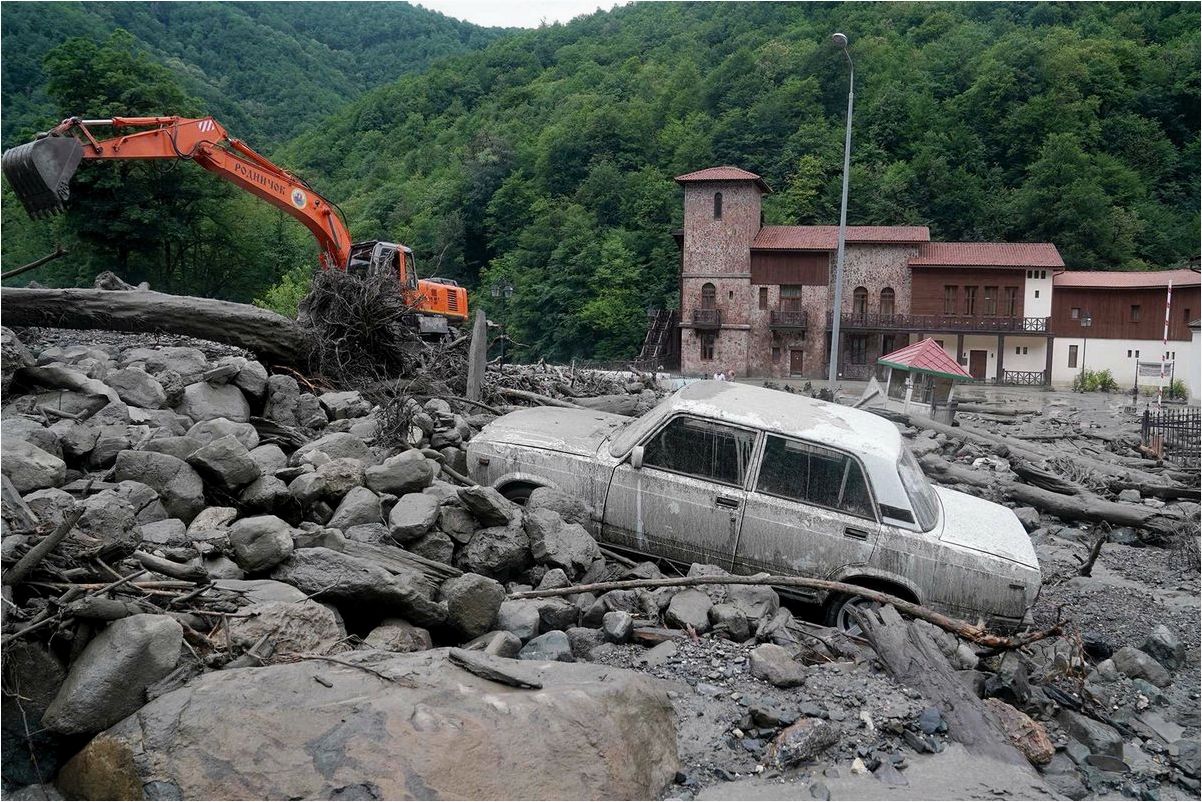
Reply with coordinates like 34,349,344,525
918,455,1180,535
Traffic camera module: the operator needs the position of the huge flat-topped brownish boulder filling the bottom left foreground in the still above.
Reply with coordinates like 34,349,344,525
59,649,679,800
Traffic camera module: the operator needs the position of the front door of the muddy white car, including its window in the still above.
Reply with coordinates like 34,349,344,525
602,415,756,569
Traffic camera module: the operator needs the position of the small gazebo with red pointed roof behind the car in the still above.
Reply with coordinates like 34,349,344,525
876,338,976,423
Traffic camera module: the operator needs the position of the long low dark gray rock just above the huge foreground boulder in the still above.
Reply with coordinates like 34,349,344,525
272,547,446,626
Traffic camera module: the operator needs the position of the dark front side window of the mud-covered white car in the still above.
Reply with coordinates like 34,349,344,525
643,417,755,487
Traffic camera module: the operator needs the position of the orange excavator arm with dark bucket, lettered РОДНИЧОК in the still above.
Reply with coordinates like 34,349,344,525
4,117,351,269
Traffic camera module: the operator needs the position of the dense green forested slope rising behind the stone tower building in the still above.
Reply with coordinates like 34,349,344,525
5,2,1200,360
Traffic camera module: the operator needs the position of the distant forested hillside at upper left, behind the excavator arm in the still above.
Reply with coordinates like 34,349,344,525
0,2,505,148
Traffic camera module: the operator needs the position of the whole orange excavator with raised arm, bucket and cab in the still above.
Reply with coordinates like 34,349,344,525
0,117,468,335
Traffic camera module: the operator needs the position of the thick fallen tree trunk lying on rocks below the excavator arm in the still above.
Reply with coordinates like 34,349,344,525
4,287,313,366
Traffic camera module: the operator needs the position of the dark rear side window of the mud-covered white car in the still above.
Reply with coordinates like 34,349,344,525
756,434,876,518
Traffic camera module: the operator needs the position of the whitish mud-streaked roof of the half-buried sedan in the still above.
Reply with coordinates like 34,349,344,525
615,380,902,463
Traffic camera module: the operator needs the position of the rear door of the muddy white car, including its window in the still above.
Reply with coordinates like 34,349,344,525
734,434,880,596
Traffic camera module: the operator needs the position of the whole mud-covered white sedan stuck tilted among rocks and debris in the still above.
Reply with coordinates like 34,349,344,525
468,381,1041,631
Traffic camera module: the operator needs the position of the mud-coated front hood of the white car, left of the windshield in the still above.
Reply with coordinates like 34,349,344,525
481,406,633,456
